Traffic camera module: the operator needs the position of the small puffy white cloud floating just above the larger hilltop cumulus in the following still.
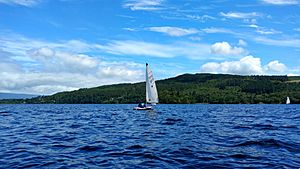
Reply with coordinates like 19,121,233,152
210,42,245,55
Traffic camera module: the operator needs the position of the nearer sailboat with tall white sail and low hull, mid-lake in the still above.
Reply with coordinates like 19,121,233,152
134,63,158,110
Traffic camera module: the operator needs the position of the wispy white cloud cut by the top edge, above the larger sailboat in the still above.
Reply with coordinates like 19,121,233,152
123,0,164,11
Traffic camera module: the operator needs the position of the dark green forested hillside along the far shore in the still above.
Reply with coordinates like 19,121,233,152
0,74,300,104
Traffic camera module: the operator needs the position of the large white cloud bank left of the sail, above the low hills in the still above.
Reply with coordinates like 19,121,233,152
0,34,144,94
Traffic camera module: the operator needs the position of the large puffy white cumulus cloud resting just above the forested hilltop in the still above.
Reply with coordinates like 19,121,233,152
200,56,286,75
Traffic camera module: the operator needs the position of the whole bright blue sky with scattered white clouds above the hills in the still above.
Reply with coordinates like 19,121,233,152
0,0,300,95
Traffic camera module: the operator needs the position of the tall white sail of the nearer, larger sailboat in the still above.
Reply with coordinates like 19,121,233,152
146,63,158,105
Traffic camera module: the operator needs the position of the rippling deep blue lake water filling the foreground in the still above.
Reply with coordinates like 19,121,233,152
0,105,300,168
